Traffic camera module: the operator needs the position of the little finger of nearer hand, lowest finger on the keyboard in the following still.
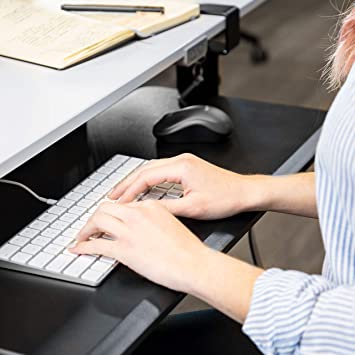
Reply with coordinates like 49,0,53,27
69,238,120,259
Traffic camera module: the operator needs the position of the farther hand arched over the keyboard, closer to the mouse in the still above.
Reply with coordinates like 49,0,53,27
108,154,258,219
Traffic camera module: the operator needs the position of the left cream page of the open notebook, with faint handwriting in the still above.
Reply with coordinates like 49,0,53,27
0,0,134,68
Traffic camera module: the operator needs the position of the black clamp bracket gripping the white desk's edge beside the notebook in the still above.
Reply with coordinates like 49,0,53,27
200,4,240,55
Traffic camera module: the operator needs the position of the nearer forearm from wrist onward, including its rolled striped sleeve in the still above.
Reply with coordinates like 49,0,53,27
185,247,355,354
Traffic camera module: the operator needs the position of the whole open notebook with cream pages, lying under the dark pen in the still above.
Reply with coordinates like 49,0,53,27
0,0,199,69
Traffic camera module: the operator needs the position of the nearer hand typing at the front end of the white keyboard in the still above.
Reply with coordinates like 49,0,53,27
70,201,208,292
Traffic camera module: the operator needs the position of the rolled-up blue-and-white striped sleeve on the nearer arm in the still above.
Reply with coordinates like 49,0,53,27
243,269,355,354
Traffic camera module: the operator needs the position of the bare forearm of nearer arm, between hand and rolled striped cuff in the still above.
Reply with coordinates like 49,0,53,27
184,247,263,323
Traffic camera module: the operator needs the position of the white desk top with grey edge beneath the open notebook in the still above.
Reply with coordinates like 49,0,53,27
0,0,264,177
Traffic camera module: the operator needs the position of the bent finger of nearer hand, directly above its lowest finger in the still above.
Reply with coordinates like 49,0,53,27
76,211,125,241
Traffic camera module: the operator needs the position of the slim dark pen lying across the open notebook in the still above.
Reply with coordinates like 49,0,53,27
61,4,164,14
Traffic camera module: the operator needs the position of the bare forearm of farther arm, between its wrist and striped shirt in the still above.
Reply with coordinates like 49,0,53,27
242,172,318,218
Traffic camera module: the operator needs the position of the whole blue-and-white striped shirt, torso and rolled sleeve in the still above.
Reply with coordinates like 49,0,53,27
243,65,355,354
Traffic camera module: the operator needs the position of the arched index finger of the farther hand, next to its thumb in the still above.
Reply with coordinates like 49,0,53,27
120,163,185,203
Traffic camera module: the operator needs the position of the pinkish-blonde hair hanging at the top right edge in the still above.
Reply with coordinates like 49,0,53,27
324,2,355,90
